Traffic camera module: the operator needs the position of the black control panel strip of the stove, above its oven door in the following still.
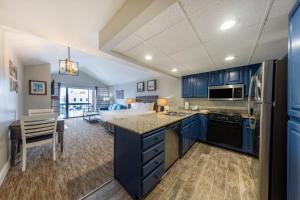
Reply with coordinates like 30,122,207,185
208,112,242,123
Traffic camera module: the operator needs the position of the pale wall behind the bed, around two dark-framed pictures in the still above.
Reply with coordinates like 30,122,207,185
109,75,182,106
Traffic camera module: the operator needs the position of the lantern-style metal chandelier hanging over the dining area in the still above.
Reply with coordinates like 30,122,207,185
59,47,79,76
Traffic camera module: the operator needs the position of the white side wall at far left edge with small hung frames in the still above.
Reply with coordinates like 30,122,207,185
0,27,23,174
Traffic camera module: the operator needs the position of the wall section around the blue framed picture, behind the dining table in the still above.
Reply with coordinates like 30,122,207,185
23,64,51,114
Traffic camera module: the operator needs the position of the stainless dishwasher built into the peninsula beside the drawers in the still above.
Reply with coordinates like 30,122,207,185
165,123,180,170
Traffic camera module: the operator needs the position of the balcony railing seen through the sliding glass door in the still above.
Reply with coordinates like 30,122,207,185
60,103,91,118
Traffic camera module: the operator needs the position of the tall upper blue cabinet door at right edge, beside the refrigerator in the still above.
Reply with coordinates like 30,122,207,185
288,3,300,118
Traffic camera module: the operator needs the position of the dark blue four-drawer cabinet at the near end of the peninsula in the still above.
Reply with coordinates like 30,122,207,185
114,127,165,199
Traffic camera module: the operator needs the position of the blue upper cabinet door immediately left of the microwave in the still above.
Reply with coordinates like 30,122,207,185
192,73,208,98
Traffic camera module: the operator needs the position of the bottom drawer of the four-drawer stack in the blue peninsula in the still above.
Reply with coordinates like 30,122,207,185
142,164,165,195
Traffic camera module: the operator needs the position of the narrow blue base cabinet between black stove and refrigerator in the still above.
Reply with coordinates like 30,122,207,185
243,119,254,154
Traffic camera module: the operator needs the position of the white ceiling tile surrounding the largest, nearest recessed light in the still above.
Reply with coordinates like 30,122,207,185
191,0,266,42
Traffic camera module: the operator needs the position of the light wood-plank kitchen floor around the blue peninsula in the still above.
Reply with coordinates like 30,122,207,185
85,143,258,200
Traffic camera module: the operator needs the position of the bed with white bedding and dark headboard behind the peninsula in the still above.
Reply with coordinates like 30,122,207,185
99,96,158,132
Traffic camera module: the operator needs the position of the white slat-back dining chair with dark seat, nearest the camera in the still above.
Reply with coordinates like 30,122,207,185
20,114,57,172
